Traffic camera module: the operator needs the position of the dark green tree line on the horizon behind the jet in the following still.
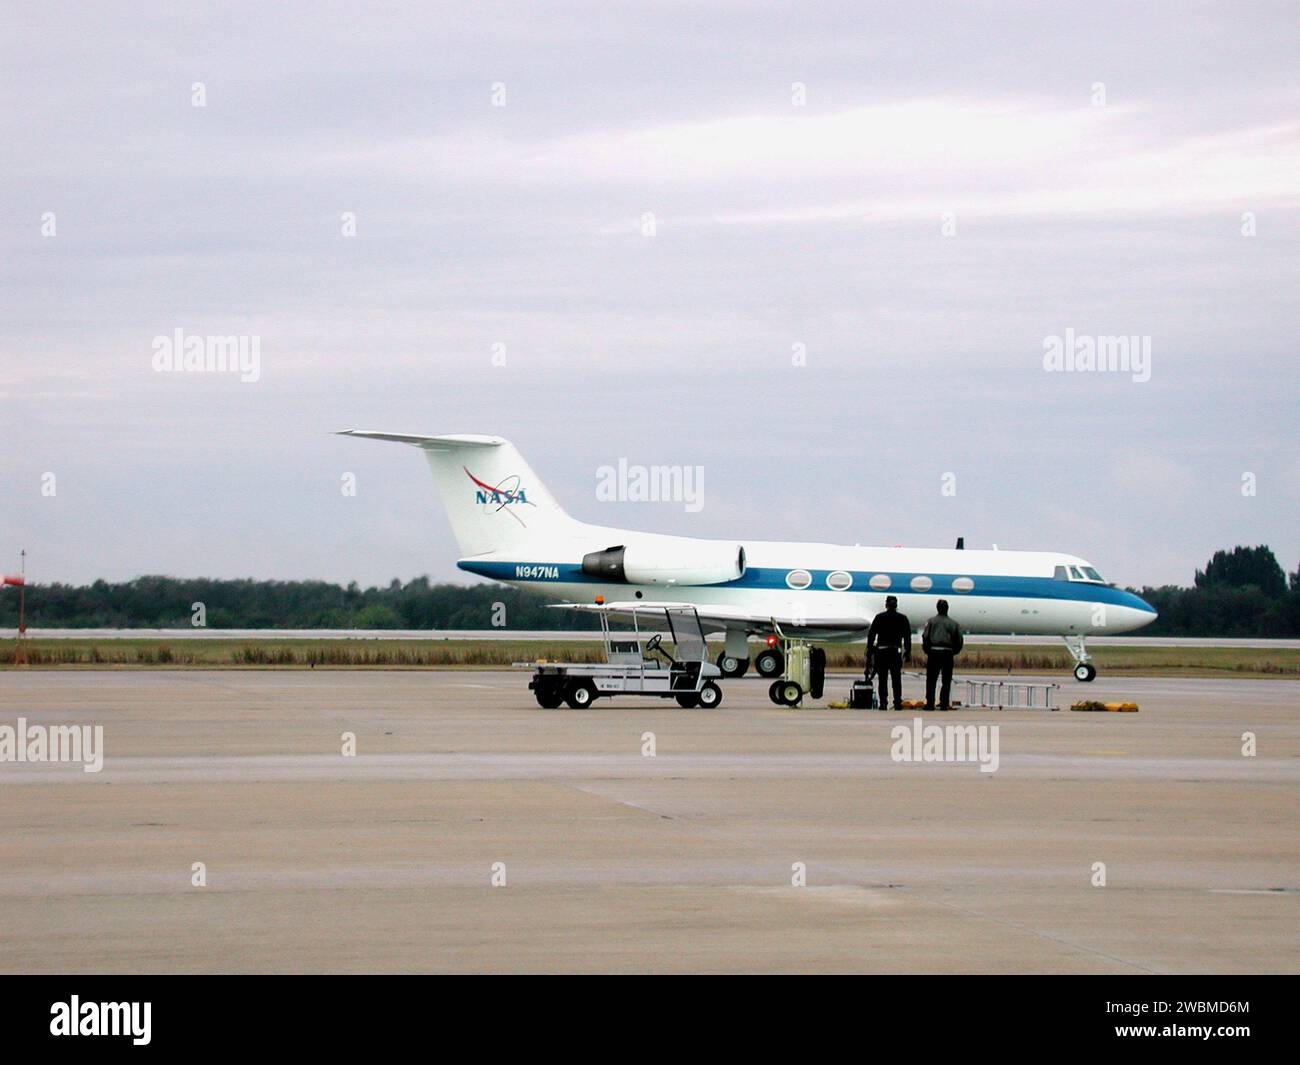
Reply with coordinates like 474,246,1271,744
0,545,1300,637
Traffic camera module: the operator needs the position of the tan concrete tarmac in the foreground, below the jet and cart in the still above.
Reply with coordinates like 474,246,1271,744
0,670,1300,973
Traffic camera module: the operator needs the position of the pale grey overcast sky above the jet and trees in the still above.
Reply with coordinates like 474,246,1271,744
0,3,1300,585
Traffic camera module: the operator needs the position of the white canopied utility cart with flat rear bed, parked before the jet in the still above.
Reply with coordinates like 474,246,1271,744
521,603,723,710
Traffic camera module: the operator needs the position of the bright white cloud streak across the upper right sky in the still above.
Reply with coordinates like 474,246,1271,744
306,99,1300,234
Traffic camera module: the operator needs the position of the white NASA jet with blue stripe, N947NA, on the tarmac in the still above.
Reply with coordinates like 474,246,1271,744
339,429,1156,680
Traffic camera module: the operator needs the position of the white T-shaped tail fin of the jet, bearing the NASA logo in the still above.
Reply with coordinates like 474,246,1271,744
339,429,580,557
